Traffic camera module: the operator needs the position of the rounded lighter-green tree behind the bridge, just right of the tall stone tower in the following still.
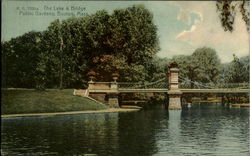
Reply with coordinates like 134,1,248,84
172,47,221,87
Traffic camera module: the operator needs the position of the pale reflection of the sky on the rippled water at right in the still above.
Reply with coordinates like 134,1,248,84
155,108,250,156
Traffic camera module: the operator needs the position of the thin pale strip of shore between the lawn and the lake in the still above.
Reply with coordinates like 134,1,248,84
1,108,140,118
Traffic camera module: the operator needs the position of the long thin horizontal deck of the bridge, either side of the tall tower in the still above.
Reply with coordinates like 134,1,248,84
89,88,250,93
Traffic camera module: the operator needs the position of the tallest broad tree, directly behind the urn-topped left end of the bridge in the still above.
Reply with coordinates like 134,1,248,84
87,5,159,81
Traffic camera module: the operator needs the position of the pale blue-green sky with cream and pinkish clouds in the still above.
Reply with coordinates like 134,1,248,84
1,0,249,63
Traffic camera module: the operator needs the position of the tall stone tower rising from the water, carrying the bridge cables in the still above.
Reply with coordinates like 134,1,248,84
168,62,182,110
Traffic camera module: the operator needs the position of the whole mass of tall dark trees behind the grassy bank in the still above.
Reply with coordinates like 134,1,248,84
2,6,159,90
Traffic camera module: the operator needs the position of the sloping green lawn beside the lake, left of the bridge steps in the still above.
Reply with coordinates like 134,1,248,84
1,89,108,114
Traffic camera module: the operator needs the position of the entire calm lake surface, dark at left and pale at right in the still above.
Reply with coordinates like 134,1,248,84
1,105,250,156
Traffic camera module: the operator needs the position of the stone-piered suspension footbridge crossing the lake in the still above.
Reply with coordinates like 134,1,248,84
81,63,250,110
